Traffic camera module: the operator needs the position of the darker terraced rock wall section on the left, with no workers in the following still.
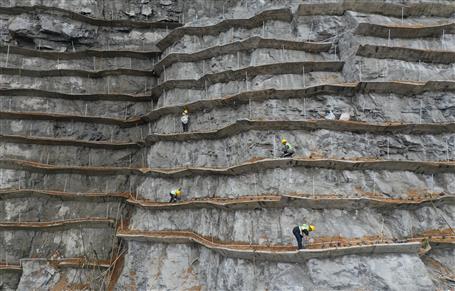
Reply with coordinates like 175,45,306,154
0,1,159,290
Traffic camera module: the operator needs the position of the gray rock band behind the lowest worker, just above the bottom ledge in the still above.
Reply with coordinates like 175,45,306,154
130,205,455,245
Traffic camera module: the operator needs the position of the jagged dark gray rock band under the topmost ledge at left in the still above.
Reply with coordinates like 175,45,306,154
5,12,166,51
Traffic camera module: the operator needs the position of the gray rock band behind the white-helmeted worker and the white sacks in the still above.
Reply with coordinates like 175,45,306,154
152,92,455,133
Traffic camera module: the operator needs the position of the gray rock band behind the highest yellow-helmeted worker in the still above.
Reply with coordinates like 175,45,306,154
148,130,454,168
